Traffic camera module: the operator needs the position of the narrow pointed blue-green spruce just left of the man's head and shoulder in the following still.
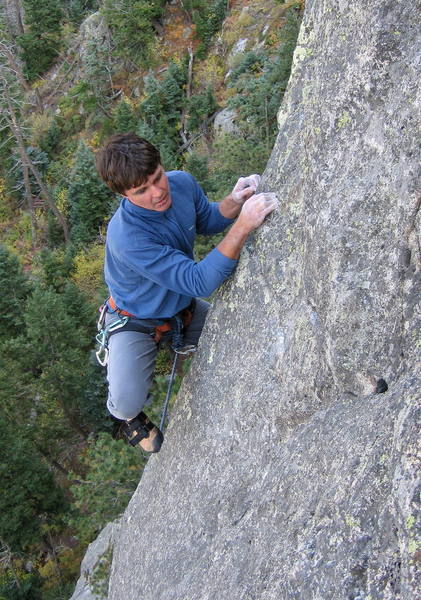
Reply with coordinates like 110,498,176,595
68,141,113,245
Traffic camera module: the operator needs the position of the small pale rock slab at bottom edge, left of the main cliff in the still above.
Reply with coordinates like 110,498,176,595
70,521,120,600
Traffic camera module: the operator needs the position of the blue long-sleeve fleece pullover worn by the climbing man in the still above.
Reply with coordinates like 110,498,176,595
105,171,237,319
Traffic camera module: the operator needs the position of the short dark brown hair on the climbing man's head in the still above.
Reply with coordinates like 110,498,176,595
96,133,161,194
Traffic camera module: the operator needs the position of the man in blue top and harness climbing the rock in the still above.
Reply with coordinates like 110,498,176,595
97,133,277,452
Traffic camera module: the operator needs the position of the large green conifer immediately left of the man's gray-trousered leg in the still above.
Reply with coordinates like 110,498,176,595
0,283,105,456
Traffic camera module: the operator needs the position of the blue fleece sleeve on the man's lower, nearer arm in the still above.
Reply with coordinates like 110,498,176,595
124,241,238,297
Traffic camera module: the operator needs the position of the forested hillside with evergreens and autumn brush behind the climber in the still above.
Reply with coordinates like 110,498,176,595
0,0,303,600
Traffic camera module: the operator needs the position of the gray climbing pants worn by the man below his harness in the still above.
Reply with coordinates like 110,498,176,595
105,298,210,419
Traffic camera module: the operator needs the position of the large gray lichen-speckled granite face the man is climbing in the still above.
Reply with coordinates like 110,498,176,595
109,0,421,600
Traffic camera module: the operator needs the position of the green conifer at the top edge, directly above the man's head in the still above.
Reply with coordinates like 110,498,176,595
101,0,164,68
